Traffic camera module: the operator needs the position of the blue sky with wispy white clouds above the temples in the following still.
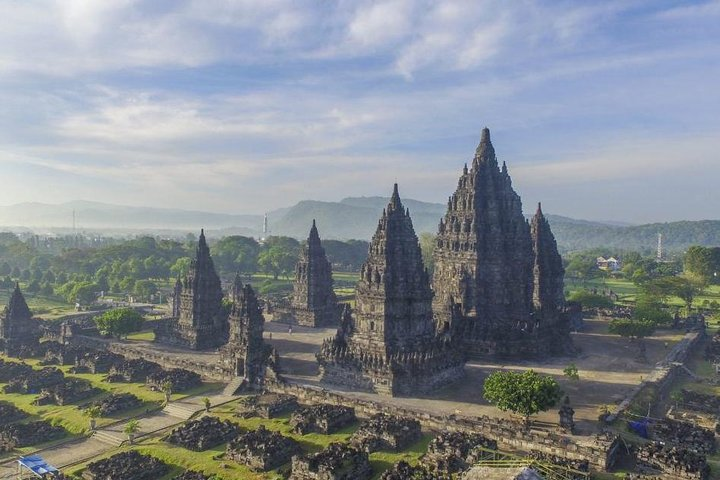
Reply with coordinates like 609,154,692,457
0,0,720,222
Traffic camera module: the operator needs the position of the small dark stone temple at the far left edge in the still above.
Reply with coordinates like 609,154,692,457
0,283,40,357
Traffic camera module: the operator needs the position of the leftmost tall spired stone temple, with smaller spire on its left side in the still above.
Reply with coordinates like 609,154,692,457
155,230,228,350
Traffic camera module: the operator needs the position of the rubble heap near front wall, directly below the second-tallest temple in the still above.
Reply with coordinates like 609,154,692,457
350,414,422,453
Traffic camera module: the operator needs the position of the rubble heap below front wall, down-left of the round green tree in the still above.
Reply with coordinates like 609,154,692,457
421,432,497,475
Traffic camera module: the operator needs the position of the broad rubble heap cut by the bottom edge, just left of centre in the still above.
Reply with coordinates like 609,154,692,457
290,443,373,480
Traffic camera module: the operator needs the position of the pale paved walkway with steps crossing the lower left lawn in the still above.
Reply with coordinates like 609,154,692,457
0,393,236,480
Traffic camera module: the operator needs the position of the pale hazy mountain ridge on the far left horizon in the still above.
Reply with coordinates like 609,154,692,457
0,201,262,231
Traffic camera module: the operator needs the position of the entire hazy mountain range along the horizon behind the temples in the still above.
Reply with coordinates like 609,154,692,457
0,197,720,251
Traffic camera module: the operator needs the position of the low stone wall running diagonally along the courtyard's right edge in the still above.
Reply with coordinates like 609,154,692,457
605,330,705,423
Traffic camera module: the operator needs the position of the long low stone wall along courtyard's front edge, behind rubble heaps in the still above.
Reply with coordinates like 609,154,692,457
268,384,618,470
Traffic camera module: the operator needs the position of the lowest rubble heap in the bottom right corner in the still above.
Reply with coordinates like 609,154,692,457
637,442,710,480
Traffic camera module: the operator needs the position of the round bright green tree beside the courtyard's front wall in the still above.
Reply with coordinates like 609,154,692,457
483,370,562,423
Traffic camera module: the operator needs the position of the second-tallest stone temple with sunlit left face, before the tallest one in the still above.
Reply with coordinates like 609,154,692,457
317,184,464,396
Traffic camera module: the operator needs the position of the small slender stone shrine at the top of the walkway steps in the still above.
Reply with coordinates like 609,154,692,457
220,277,270,384
